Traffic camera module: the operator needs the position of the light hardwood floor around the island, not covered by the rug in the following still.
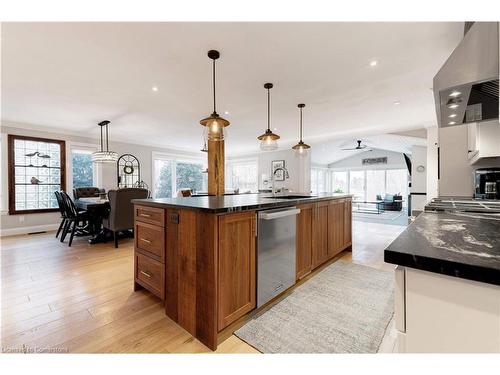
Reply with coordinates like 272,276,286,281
1,222,404,353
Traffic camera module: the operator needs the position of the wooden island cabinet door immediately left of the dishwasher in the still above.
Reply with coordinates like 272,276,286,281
218,212,256,331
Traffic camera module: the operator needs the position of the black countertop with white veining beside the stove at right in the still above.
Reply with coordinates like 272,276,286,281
384,212,500,285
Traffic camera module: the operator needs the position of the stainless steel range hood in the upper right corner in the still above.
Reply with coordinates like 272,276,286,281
433,22,499,127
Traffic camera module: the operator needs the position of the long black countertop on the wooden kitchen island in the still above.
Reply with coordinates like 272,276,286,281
132,193,351,213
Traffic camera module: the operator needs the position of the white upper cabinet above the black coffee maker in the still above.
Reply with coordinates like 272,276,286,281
467,120,500,164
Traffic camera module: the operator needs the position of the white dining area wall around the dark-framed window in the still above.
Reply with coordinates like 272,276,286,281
0,124,200,235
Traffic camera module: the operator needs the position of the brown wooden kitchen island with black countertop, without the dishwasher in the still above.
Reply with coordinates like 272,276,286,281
133,194,352,350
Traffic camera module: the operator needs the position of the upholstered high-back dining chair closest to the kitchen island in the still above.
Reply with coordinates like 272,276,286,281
102,188,148,248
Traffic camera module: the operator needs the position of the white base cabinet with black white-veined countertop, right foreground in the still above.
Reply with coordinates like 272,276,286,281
384,208,500,353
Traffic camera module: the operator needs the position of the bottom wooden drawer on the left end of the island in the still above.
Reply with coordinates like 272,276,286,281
135,253,165,299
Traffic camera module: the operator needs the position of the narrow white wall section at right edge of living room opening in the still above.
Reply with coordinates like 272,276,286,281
410,146,427,211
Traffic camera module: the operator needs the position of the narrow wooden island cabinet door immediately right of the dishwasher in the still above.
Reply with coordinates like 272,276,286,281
296,204,314,280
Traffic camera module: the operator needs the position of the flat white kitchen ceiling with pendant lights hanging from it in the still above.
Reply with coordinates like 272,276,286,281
2,22,463,162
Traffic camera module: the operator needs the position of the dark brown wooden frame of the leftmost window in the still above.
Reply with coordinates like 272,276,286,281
7,134,66,215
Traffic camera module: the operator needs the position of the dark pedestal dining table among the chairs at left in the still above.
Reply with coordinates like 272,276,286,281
74,197,112,245
